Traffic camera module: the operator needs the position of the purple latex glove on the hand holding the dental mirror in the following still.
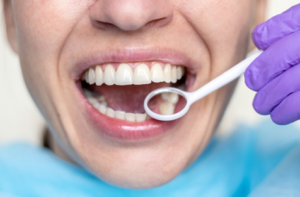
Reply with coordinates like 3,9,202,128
245,4,300,125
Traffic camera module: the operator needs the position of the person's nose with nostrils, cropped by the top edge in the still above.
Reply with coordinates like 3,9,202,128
90,0,173,31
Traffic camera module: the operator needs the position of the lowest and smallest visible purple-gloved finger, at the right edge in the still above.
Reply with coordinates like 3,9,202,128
271,92,300,125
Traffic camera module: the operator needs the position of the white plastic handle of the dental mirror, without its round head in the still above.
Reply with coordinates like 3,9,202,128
188,50,263,105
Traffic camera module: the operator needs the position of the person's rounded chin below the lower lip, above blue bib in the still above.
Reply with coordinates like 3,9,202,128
74,138,190,189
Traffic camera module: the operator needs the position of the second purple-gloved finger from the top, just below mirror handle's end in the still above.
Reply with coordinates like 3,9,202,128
245,31,300,91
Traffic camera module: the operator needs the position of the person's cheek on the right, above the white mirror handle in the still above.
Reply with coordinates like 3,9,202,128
181,0,253,90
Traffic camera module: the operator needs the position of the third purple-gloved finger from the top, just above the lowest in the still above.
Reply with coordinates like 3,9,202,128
253,64,300,115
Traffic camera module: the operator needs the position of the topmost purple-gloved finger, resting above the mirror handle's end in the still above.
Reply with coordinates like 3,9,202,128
252,4,300,50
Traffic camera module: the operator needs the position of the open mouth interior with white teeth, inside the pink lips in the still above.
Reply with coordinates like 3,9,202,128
81,62,186,123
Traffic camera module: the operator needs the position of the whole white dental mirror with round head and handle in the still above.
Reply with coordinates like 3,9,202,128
144,51,263,121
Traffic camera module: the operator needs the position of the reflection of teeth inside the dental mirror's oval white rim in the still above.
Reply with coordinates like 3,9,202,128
148,92,186,115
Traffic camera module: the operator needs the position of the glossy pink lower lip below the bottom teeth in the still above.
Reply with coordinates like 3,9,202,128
77,82,177,141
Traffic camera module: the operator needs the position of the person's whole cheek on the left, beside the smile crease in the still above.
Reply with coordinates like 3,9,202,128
12,0,90,103
